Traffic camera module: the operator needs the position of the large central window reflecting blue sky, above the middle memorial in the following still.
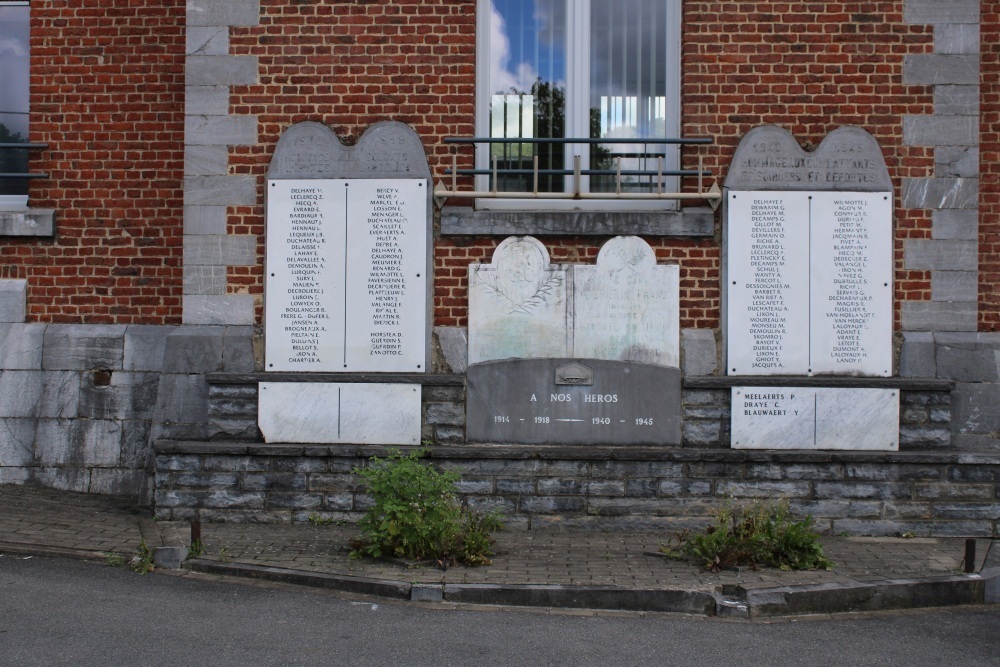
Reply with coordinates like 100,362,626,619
476,0,681,208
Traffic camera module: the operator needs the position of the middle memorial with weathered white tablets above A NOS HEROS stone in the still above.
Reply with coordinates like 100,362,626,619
466,236,680,445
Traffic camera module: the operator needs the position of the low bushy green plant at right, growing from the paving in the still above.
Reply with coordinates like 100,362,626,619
660,500,833,572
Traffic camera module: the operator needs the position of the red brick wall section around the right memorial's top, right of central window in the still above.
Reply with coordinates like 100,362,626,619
681,0,934,328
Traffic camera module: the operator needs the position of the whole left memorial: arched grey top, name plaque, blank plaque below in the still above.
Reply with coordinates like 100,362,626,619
259,122,433,444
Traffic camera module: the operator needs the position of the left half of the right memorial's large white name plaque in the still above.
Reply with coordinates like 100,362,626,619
727,192,809,375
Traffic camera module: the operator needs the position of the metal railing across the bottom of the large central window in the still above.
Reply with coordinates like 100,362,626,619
434,137,722,208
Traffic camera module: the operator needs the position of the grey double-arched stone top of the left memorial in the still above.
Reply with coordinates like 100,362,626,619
267,120,431,179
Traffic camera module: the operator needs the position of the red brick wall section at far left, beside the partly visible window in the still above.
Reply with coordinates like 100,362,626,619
0,0,185,324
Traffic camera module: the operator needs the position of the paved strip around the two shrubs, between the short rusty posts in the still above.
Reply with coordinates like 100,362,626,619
202,524,988,590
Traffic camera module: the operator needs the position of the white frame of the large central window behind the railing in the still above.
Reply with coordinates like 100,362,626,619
475,0,683,211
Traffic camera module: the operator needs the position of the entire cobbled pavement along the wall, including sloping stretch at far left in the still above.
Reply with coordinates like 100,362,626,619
0,486,989,590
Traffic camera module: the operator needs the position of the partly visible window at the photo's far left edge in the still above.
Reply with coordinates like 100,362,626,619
0,2,28,210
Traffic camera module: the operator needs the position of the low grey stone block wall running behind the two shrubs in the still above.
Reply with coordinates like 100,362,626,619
154,441,1000,537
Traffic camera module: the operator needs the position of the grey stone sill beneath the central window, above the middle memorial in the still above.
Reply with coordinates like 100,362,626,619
441,206,715,237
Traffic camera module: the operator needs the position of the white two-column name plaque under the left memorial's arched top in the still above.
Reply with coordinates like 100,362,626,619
265,179,427,372
